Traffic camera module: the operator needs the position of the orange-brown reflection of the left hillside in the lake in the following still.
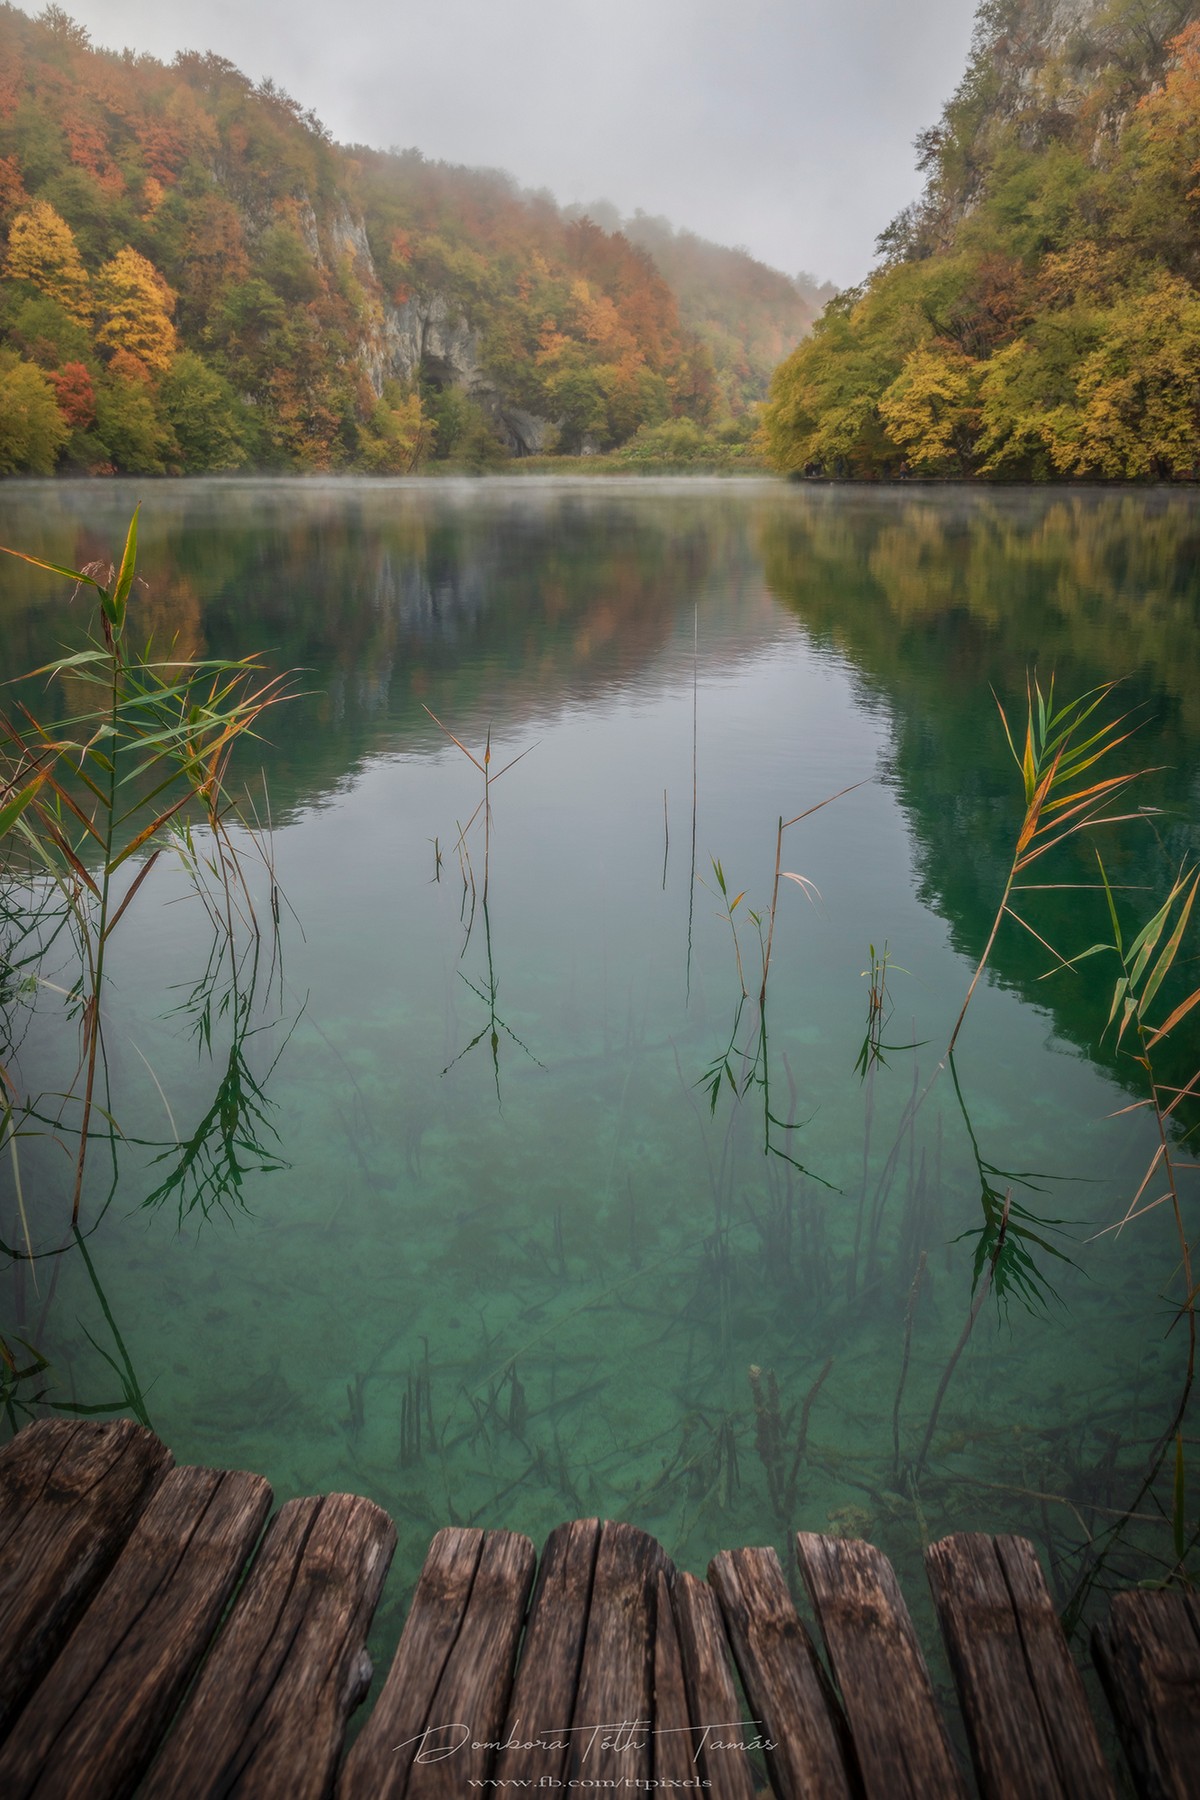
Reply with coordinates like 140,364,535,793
0,482,777,817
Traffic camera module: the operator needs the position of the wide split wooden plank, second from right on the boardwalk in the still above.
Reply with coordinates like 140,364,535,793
925,1532,1115,1800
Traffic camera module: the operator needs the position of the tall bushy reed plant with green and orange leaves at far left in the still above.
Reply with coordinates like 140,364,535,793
0,511,288,1256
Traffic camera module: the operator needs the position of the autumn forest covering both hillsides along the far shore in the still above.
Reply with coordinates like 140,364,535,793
0,0,1200,481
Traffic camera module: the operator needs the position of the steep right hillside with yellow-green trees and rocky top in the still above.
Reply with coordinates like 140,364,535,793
765,0,1200,481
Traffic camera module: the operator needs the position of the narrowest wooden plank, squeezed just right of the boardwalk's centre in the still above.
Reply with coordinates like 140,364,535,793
672,1570,756,1800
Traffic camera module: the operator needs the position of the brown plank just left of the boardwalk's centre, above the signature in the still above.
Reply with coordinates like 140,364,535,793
495,1519,601,1782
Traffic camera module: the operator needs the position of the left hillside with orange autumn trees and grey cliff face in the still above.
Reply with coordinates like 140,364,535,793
0,5,815,473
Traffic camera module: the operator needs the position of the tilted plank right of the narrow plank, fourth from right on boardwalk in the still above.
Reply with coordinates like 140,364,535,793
709,1550,855,1800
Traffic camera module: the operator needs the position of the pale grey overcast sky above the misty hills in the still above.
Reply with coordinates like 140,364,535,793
22,0,975,284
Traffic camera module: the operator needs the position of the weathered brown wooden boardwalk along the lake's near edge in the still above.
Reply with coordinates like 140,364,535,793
0,1420,1200,1800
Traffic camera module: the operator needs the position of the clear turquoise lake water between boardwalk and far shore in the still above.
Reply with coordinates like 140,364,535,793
0,481,1200,1642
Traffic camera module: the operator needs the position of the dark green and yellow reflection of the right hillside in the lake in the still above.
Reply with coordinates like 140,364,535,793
761,493,1200,1094
